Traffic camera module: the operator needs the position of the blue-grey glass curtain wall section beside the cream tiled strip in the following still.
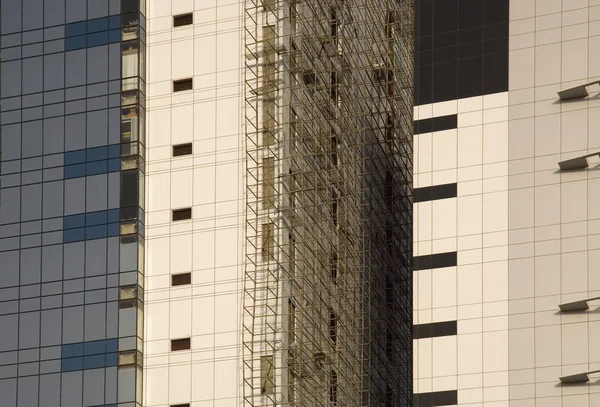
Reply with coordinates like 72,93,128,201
0,0,146,407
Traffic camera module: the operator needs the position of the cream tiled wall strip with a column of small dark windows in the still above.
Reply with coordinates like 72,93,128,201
144,0,244,407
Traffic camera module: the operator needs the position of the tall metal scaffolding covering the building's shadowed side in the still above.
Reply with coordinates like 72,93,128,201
243,0,413,407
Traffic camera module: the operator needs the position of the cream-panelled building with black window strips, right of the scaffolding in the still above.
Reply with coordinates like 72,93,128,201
413,0,600,407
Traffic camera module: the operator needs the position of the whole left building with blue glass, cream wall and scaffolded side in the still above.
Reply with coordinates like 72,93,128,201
0,0,413,407
